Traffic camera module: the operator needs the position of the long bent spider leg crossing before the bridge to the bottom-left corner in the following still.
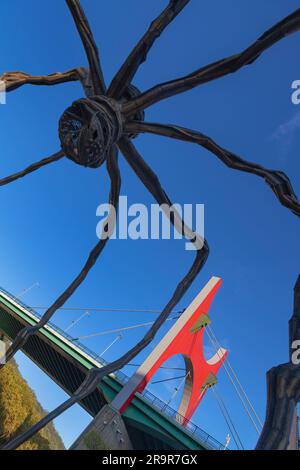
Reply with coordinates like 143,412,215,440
2,137,209,450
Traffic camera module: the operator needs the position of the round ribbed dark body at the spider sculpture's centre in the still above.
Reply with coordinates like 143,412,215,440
59,96,122,168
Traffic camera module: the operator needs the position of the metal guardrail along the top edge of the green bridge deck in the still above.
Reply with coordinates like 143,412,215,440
0,287,224,450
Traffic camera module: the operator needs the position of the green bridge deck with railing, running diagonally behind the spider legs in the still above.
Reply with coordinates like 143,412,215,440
0,288,224,450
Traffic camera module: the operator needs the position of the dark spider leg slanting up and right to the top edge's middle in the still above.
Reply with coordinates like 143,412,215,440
107,0,190,100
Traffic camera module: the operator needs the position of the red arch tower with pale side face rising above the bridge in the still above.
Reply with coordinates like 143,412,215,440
112,277,227,425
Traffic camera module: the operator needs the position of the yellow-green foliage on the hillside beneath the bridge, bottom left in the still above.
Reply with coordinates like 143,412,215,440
0,361,64,450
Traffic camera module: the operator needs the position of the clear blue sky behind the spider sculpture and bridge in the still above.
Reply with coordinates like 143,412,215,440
0,0,300,448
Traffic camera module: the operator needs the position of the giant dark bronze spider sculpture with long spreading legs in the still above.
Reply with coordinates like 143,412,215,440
0,0,300,449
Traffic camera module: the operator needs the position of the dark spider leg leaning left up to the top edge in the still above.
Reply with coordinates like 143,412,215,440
66,0,106,95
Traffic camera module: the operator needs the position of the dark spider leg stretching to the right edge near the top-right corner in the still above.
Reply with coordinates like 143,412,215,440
123,9,300,115
